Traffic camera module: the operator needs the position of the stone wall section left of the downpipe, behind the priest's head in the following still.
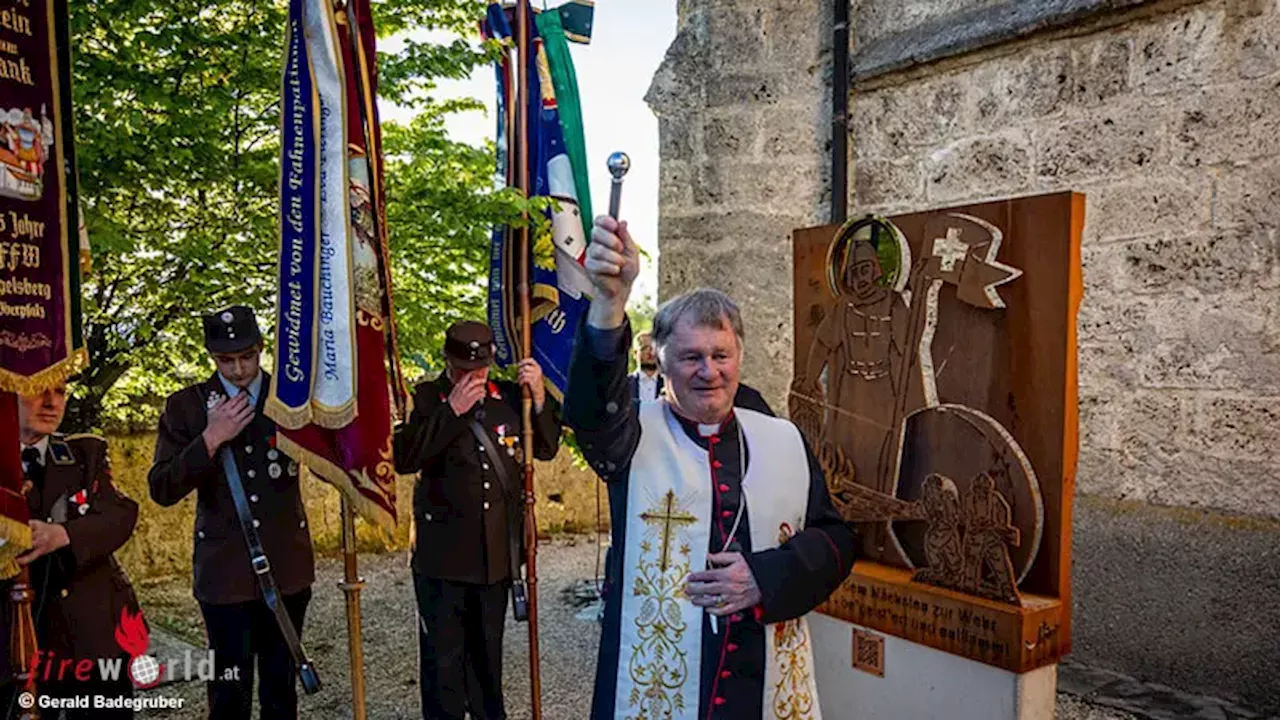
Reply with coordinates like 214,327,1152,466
640,0,831,409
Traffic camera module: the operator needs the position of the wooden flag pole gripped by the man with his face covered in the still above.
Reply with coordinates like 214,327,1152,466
512,0,543,720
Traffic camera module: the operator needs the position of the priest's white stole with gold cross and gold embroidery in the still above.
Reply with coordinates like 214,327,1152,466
614,398,822,720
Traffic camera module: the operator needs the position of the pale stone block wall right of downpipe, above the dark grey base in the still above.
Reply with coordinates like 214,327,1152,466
852,0,1280,518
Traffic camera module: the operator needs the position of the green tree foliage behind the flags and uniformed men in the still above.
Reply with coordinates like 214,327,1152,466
68,0,513,429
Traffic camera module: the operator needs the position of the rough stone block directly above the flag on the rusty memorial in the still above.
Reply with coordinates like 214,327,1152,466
925,132,1032,202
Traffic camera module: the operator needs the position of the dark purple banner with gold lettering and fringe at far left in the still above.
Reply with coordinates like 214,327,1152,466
0,0,88,395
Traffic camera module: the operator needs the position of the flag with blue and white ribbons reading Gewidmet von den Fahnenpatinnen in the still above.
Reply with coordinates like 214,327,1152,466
266,0,407,530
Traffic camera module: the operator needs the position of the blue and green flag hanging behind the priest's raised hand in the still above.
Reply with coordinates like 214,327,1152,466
484,4,591,398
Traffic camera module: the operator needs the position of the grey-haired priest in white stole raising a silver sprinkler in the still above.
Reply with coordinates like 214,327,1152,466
564,217,855,720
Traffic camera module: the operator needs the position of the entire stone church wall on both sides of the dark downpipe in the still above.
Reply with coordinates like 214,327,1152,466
650,0,1280,712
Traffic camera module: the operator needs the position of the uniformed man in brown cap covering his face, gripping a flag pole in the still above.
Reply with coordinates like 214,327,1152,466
396,322,561,720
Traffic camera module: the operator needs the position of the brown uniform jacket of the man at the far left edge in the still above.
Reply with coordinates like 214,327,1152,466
0,434,138,680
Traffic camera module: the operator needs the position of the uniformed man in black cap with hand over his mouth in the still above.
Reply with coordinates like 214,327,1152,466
148,306,315,720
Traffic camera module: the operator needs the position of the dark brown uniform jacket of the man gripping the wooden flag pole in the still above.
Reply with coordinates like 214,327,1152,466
396,373,561,584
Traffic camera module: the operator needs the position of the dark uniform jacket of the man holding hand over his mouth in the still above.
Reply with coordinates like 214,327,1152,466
147,372,315,605
